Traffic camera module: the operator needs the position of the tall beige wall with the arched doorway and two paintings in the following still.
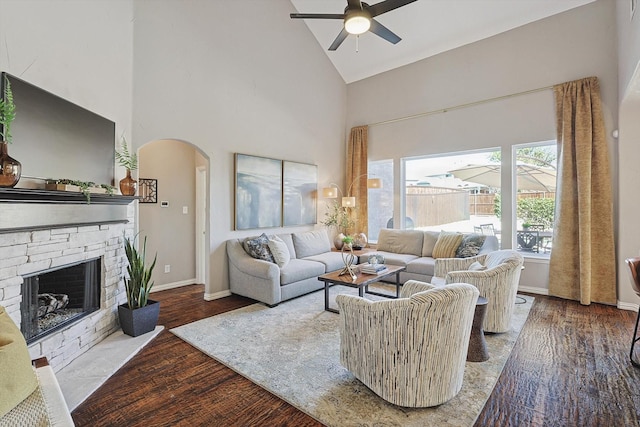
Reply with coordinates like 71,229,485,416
133,0,346,297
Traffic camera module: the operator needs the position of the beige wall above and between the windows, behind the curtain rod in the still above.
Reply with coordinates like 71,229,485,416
347,0,618,300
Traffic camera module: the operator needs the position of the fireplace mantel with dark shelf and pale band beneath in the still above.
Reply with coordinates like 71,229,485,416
0,188,138,234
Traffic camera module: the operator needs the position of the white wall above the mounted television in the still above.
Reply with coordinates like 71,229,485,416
0,0,133,149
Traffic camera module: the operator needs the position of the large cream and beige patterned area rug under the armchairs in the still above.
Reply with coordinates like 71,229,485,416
171,286,533,427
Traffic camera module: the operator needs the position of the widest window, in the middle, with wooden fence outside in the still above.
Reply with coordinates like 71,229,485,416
396,150,501,237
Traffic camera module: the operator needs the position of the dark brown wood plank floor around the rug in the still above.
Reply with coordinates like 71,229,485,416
72,285,640,426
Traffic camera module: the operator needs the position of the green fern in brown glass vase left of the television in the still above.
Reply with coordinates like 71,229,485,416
0,74,22,187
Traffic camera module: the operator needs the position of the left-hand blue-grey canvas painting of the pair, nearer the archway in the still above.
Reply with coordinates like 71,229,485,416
235,153,282,230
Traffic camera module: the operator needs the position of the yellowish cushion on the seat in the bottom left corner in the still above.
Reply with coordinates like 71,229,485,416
0,306,38,418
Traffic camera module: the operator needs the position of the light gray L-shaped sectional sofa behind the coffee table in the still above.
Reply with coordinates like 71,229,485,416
227,229,498,306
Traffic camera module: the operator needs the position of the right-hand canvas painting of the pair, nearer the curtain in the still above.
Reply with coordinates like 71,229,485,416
282,160,318,226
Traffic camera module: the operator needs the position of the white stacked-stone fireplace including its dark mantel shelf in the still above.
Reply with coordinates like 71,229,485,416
0,189,135,371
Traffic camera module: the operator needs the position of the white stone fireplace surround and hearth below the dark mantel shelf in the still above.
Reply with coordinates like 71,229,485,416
0,194,135,371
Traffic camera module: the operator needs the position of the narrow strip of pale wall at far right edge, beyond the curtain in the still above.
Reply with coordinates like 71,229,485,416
617,2,640,310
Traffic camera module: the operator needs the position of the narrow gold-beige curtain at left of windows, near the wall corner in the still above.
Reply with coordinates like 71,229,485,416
345,126,369,235
